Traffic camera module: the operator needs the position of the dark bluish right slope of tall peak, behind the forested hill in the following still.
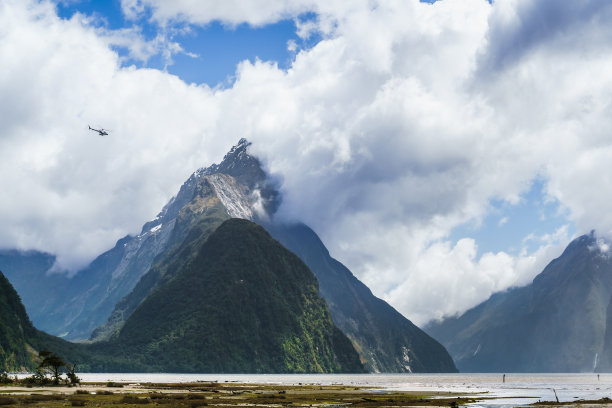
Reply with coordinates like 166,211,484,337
266,224,457,372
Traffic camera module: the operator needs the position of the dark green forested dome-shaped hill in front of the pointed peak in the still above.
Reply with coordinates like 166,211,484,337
91,219,363,373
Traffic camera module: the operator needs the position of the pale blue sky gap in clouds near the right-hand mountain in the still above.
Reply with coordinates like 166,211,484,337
449,179,575,255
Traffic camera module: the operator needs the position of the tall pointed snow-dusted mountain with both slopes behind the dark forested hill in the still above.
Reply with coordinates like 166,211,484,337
0,139,456,372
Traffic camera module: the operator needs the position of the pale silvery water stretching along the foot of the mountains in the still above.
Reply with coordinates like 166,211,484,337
74,373,612,408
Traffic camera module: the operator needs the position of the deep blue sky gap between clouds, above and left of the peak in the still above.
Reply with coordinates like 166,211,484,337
57,0,321,87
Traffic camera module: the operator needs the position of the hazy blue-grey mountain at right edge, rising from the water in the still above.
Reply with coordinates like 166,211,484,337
426,234,612,372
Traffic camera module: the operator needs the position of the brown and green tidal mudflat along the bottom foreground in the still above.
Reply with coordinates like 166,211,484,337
0,382,483,408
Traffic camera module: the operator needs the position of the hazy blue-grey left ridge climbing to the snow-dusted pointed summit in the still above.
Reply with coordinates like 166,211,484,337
0,140,277,340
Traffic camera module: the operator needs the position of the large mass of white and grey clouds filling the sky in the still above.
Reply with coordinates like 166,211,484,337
0,0,612,323
